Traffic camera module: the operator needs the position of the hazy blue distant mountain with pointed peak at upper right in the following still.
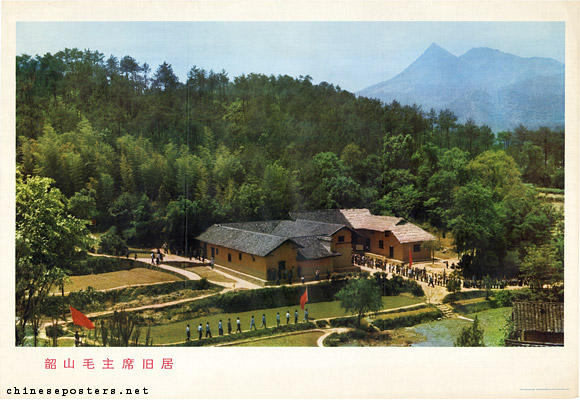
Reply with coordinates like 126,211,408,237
357,43,565,132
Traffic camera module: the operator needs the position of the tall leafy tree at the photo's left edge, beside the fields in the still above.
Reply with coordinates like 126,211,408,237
15,172,90,345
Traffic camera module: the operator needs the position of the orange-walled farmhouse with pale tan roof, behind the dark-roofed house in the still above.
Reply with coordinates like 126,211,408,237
290,208,435,262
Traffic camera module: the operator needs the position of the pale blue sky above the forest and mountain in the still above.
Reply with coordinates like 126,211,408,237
16,22,565,92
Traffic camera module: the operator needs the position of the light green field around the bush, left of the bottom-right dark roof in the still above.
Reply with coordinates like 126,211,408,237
413,307,511,347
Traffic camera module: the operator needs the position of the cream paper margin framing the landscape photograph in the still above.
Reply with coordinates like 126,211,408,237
0,1,579,398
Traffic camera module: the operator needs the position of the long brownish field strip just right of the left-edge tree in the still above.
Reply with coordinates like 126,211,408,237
64,268,180,292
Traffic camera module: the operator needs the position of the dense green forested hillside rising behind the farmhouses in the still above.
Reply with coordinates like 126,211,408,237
16,49,564,280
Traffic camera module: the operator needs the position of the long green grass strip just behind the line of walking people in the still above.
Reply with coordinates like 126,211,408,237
151,295,425,345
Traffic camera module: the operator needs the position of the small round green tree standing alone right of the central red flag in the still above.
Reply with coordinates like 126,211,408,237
336,278,383,326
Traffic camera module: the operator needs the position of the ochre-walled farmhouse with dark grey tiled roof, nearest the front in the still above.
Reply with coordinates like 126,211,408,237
196,219,352,281
